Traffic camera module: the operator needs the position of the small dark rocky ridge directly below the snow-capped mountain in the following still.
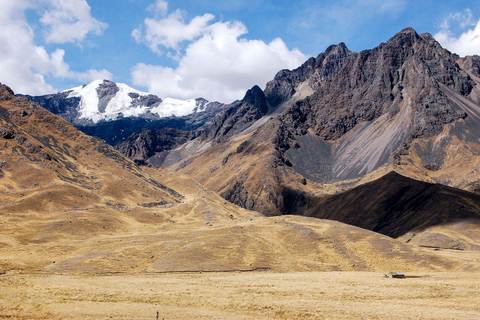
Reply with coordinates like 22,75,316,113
115,128,193,164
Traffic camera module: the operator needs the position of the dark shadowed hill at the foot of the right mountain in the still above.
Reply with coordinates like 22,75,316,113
305,172,480,238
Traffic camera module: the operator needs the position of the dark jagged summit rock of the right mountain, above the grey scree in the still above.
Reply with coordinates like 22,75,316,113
276,28,474,140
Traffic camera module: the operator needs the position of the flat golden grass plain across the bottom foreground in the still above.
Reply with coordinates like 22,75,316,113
0,271,480,320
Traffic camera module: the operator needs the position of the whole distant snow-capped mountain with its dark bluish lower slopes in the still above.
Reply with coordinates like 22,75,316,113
21,80,223,145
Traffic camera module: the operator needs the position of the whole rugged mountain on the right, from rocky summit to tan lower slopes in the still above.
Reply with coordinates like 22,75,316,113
129,28,480,215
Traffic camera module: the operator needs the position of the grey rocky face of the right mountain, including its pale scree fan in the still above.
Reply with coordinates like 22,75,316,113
267,28,476,182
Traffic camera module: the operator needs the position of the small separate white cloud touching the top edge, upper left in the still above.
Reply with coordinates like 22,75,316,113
40,0,107,43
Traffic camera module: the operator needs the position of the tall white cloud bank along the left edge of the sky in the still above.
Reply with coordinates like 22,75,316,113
0,0,112,95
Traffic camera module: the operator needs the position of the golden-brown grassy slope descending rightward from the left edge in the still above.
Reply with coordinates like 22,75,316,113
0,85,182,220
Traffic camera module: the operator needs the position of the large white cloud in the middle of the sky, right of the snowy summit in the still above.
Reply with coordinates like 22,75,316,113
132,1,307,102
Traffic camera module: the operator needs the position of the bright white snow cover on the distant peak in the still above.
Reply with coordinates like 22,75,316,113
62,80,212,123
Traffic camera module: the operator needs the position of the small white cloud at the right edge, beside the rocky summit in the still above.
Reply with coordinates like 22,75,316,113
434,9,480,56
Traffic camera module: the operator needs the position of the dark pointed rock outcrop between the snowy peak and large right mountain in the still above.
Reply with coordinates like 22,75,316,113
198,86,268,142
